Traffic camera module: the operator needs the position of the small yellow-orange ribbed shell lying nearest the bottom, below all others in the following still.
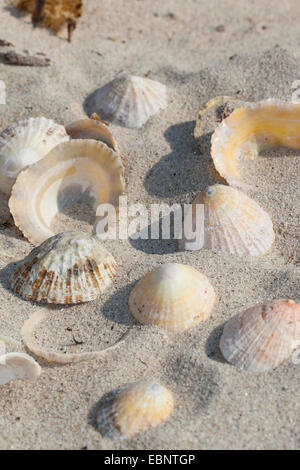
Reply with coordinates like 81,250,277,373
97,381,174,439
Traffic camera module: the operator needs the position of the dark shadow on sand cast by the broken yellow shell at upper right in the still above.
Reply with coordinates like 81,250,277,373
144,121,222,198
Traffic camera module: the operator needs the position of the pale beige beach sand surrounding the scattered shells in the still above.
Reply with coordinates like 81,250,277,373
0,0,300,450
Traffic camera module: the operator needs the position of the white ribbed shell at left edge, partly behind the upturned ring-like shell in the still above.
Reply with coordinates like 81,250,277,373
0,117,69,195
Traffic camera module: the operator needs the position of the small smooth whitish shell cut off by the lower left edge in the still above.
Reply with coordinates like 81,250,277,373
0,353,42,385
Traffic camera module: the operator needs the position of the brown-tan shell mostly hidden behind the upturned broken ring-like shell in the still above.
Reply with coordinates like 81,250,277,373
66,119,118,152
